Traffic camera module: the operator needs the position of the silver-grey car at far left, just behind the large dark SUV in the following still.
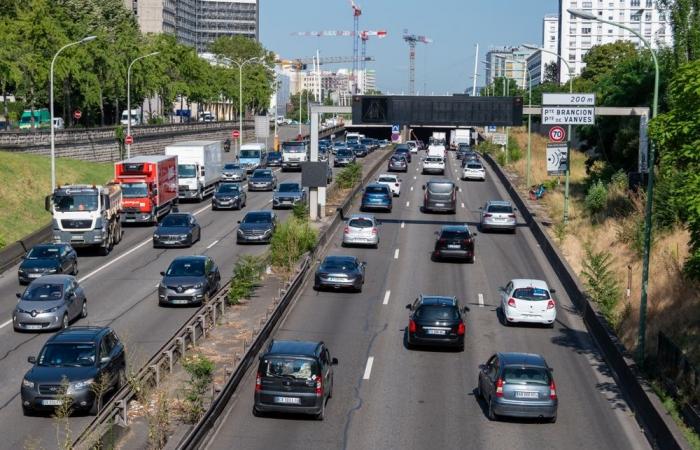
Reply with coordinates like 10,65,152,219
12,275,87,331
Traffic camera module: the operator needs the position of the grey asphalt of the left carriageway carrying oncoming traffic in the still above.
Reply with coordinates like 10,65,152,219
0,127,366,449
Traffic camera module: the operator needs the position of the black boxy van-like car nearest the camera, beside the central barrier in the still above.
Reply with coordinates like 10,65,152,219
253,339,338,420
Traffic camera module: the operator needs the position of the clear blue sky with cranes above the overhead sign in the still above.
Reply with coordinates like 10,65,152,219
259,0,559,94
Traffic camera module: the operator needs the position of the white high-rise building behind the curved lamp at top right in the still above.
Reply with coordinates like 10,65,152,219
559,0,673,83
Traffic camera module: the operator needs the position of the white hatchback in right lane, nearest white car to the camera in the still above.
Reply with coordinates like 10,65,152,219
501,278,557,328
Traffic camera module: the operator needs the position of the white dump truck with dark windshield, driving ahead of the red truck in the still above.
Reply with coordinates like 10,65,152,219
44,183,122,255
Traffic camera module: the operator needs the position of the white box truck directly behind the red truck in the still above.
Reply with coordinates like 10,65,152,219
165,141,224,202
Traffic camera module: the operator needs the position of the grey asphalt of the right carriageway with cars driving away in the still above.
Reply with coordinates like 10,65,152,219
202,149,650,450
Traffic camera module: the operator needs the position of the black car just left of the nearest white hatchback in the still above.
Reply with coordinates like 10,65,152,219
405,294,469,351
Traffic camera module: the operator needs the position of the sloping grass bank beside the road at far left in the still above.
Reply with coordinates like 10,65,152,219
0,151,114,246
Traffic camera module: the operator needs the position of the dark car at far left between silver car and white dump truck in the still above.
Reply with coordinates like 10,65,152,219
17,243,78,284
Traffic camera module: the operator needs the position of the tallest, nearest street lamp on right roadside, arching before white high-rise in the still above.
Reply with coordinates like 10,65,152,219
567,9,659,364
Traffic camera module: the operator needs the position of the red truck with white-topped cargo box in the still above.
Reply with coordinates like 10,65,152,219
114,155,178,224
